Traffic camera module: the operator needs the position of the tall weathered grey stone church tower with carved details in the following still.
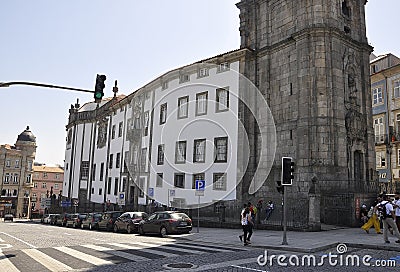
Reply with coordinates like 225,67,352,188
237,0,377,229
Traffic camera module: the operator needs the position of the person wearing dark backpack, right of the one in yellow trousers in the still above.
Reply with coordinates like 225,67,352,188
377,195,400,244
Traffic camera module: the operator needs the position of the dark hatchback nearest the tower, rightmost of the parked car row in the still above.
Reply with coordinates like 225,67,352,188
139,211,192,237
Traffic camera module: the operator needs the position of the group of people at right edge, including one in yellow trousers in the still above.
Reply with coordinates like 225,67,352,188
361,193,400,243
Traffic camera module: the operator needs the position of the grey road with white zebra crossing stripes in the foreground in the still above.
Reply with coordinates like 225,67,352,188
0,222,400,272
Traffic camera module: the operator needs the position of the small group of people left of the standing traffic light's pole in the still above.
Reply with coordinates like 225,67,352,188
239,200,274,246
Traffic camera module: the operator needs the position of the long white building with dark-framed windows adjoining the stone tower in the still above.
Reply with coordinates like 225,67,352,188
63,49,248,209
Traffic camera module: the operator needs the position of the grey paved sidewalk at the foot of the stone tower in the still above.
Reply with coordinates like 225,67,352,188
174,227,400,253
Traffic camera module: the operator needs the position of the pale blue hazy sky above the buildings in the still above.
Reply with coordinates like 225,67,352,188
0,0,400,165
